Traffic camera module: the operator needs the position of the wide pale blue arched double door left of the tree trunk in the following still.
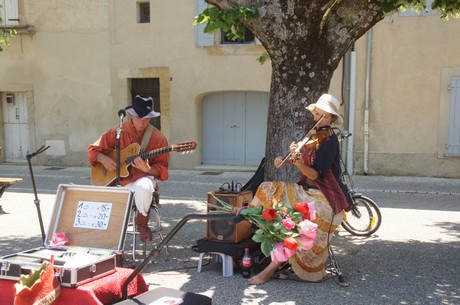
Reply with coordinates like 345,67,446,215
202,91,269,166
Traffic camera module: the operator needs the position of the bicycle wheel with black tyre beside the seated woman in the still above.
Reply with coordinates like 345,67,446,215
342,195,382,236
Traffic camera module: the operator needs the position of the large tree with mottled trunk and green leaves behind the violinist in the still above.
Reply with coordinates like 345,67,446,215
196,0,460,181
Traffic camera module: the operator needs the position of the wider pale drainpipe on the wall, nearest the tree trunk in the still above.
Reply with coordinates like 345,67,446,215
347,50,356,175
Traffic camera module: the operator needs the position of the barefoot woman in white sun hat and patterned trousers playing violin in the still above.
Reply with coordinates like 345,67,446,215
249,94,352,285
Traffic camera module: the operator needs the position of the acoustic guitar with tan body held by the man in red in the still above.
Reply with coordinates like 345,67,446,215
91,142,197,186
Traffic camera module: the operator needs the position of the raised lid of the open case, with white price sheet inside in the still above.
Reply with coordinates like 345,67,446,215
45,184,133,251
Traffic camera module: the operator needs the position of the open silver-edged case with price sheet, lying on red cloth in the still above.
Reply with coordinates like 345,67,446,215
0,184,133,287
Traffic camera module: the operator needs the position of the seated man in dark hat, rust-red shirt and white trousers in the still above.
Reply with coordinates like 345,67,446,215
88,95,169,243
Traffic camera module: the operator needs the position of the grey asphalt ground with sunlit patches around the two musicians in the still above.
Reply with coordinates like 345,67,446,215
0,164,460,305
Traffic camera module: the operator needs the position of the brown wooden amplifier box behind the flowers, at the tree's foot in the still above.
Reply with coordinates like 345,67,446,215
206,191,252,243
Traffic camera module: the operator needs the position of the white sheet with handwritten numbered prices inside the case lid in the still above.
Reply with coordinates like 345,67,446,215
73,201,112,230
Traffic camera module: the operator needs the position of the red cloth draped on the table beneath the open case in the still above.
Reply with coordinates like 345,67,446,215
0,268,148,305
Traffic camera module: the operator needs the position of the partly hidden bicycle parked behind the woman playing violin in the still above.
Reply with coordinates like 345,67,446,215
334,127,382,236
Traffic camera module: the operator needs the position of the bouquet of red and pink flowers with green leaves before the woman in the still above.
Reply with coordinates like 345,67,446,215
208,197,317,263
